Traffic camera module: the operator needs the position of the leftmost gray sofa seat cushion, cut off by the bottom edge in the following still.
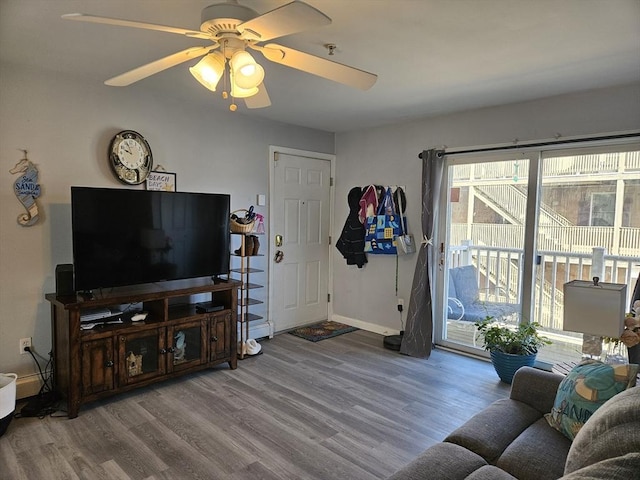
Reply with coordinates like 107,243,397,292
388,443,487,480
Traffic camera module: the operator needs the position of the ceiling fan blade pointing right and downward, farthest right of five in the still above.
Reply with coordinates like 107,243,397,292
258,43,378,90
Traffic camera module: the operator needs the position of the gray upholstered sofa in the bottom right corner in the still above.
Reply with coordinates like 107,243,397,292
389,367,640,480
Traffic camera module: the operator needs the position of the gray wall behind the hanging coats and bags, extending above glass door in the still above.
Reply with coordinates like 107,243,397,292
333,84,640,333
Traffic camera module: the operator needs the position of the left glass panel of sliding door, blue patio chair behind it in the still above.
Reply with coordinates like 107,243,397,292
440,152,530,350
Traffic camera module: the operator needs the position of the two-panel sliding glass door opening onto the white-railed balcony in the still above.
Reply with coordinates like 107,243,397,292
434,144,640,364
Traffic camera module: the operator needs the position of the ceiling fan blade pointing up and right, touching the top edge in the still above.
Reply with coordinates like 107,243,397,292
238,2,331,42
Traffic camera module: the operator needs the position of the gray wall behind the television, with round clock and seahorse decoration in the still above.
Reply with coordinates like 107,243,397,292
0,64,334,388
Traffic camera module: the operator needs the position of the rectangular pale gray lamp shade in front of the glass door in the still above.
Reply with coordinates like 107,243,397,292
562,280,627,338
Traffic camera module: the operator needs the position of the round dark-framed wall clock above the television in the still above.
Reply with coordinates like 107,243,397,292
109,130,153,185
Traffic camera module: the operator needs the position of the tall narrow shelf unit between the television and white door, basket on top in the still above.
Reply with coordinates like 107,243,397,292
230,233,273,359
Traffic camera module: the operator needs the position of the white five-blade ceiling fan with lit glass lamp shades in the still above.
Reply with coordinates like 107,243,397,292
62,0,378,111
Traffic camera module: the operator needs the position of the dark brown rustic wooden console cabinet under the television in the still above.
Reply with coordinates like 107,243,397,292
45,278,240,418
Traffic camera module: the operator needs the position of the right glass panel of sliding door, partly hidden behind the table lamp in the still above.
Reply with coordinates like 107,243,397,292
533,146,640,363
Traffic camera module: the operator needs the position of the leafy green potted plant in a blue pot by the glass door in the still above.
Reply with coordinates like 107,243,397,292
475,317,551,383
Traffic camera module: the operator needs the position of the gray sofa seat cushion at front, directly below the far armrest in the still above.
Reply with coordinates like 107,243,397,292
445,398,542,463
